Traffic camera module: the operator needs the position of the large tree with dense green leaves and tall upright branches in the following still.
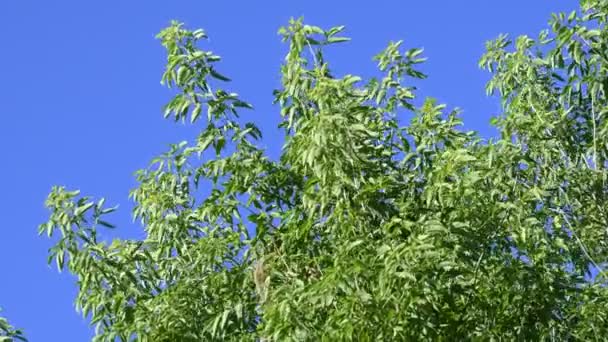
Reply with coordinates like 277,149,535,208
4,0,608,341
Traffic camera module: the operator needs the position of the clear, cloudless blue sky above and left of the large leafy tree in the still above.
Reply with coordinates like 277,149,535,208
0,0,578,342
